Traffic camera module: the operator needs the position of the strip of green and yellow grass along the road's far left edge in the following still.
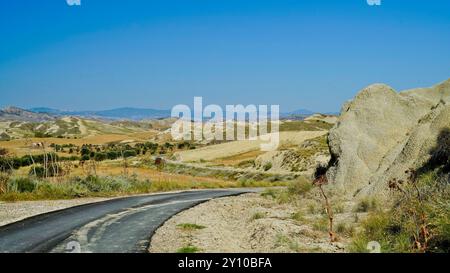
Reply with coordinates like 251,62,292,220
0,175,284,202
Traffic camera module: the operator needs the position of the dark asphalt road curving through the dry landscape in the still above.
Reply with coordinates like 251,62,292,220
0,189,252,253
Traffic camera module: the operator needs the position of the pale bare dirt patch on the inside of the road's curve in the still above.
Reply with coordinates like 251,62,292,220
149,194,345,253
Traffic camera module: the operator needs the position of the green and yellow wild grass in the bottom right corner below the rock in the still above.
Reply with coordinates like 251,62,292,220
351,171,450,253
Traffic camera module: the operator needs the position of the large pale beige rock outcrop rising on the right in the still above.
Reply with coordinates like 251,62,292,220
327,80,450,196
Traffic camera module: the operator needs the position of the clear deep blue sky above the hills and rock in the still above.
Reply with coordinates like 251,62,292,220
0,0,450,112
